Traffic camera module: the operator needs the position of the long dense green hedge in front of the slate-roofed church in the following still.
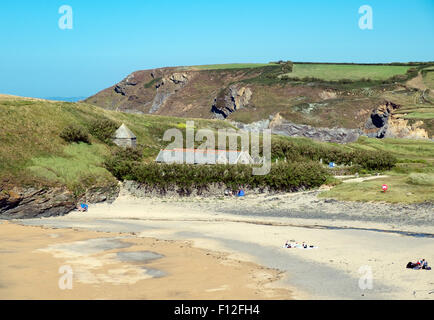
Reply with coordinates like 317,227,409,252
106,156,328,193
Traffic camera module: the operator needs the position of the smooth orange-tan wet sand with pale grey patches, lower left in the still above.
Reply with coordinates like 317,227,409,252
0,222,291,300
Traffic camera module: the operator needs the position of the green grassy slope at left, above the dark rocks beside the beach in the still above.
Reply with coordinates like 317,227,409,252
0,97,234,194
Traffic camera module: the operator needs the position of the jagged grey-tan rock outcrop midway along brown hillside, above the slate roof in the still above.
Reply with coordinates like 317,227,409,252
211,85,252,119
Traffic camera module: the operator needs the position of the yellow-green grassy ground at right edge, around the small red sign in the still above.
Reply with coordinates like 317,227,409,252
320,137,434,203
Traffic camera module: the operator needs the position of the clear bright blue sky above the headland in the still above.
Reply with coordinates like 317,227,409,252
0,0,434,97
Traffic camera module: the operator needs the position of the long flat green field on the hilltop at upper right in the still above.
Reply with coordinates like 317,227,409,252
286,64,410,81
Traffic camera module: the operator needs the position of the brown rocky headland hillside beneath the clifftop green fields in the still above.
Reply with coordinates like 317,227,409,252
86,67,432,142
